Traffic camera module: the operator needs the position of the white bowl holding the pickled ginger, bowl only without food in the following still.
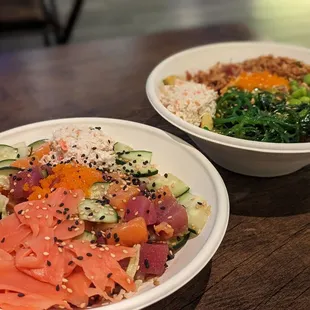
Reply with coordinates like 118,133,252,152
0,118,229,310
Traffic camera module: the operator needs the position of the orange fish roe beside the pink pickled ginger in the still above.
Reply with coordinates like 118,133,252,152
28,164,102,200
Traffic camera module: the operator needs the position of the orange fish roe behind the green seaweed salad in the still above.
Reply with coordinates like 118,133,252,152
228,71,289,91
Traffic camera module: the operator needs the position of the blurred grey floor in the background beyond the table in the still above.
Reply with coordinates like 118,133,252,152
0,0,310,52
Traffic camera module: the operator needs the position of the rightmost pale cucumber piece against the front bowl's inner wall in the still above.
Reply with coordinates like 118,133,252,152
178,193,210,234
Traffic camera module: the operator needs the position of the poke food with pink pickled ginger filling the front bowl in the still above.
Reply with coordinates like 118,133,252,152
0,126,210,309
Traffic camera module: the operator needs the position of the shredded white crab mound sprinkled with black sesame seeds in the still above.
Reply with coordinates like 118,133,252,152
41,126,115,169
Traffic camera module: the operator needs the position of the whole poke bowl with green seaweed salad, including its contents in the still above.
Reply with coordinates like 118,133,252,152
146,42,310,177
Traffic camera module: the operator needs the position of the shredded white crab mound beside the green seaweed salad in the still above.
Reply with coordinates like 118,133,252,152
160,79,218,126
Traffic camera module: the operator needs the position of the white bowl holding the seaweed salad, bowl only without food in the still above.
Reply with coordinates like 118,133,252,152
146,42,310,177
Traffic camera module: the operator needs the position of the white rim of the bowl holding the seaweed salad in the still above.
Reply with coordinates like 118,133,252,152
145,41,310,154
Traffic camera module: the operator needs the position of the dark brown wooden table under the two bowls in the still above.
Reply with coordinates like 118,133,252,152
0,25,310,310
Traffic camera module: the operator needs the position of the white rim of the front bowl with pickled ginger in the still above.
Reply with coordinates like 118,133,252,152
0,117,230,310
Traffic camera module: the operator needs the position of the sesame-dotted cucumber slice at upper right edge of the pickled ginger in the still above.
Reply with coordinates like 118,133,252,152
79,199,118,223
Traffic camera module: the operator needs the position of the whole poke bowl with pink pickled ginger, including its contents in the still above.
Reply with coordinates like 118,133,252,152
0,118,229,310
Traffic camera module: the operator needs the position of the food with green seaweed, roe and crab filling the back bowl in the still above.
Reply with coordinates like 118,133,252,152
160,55,310,143
